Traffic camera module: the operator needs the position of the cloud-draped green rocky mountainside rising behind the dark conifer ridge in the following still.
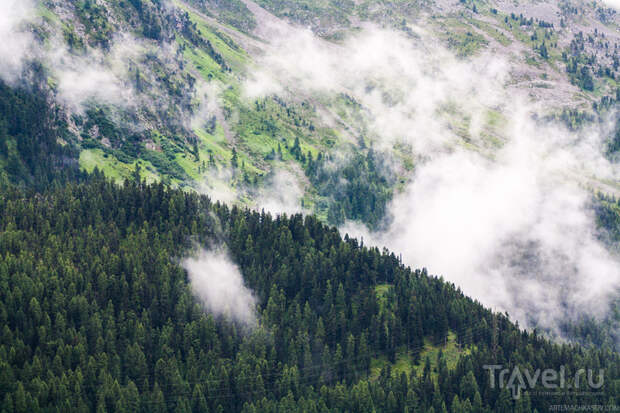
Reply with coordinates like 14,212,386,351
0,0,620,392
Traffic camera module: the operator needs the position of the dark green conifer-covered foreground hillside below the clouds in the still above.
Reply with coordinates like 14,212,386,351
0,173,620,412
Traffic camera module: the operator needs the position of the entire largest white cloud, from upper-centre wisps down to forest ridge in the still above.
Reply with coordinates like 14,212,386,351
246,14,620,334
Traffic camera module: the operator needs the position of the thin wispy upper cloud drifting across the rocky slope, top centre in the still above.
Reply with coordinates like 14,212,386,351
244,25,508,153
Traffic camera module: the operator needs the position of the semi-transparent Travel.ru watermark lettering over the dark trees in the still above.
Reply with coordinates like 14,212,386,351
482,364,605,400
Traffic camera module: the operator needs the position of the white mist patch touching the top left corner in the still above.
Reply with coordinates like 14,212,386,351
0,0,139,108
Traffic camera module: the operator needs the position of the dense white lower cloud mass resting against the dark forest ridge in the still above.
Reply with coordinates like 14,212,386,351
343,106,620,331
